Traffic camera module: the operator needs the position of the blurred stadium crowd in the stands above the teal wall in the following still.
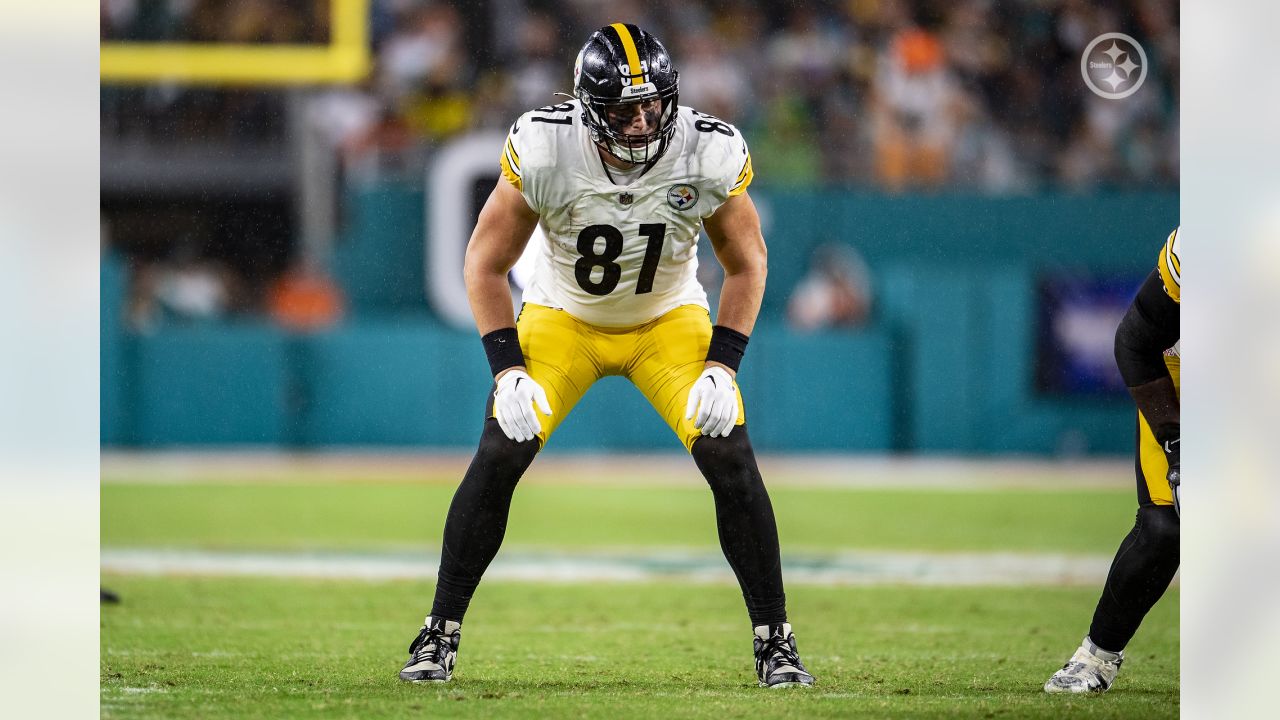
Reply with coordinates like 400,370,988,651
101,0,1179,193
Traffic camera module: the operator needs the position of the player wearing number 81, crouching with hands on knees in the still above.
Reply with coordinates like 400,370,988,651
399,23,814,687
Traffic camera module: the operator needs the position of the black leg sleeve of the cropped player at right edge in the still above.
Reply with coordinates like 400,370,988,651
1089,505,1181,652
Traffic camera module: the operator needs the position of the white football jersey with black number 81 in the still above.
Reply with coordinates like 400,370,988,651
499,100,754,328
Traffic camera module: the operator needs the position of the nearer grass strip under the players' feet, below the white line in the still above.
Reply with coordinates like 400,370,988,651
101,575,1178,719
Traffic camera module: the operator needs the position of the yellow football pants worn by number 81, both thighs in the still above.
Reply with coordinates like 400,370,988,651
490,304,746,450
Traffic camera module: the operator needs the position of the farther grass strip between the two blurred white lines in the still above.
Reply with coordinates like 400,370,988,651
101,483,1135,555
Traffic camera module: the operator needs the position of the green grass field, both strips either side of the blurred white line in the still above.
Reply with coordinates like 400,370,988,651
101,461,1179,719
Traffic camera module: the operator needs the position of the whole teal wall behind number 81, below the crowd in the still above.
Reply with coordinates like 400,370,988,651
101,187,1178,454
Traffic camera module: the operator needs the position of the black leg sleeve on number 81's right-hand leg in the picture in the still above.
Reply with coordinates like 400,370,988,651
692,425,787,625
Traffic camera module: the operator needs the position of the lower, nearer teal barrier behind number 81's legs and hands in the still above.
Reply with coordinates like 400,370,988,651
102,322,892,450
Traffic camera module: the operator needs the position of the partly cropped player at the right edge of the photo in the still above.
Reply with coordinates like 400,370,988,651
1044,229,1181,693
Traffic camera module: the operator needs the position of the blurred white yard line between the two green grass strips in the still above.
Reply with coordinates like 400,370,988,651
101,548,1157,585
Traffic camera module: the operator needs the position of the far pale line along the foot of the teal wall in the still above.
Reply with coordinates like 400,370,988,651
101,451,1134,491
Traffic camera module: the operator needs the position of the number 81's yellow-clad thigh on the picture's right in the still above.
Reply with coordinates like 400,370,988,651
628,305,746,450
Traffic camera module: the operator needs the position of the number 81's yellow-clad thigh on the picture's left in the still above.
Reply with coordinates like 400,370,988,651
489,305,600,447
